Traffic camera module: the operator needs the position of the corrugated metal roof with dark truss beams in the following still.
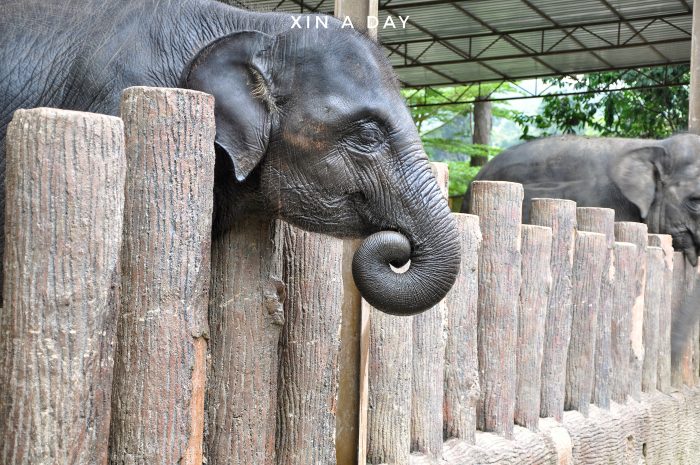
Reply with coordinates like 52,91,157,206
226,0,692,87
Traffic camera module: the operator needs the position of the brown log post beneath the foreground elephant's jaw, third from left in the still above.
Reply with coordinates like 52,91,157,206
205,217,286,465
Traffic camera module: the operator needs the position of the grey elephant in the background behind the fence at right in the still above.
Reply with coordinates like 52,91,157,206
462,134,700,360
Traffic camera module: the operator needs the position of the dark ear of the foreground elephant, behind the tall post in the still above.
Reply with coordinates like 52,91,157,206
180,31,274,181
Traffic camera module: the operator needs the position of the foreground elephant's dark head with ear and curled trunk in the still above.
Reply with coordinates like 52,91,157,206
181,25,460,315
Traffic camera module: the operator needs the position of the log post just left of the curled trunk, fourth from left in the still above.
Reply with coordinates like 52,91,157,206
276,223,343,465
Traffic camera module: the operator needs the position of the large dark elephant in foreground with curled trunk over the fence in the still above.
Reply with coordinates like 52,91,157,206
0,0,460,315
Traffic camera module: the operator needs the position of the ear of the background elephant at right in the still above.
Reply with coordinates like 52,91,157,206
610,145,666,219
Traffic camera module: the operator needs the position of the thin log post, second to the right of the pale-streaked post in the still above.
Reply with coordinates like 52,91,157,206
647,234,673,392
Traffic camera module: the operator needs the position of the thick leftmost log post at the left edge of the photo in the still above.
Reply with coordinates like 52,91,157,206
0,108,126,465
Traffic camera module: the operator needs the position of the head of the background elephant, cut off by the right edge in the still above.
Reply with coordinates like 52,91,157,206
611,134,700,266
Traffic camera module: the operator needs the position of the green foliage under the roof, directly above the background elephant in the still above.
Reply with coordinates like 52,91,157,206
514,65,690,139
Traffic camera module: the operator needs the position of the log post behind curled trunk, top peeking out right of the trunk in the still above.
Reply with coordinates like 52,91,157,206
411,163,449,459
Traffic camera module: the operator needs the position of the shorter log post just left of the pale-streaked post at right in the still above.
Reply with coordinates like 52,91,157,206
610,242,638,403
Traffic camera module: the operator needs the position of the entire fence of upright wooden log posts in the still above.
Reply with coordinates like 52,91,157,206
0,88,700,465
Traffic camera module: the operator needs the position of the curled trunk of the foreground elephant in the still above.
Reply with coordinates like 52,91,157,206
352,170,460,316
